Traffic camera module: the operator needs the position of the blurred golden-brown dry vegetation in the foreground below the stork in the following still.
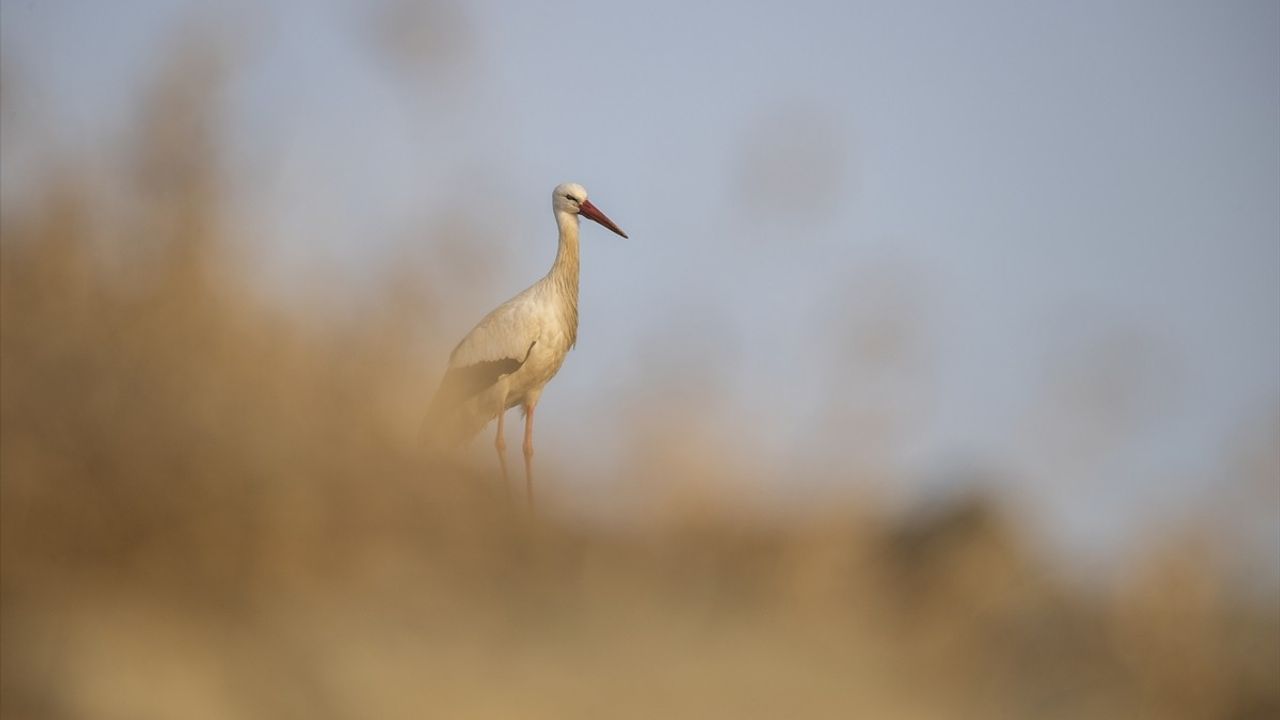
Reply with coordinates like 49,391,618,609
0,49,1280,720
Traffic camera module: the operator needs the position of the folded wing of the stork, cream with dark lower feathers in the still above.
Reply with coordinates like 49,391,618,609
429,297,540,416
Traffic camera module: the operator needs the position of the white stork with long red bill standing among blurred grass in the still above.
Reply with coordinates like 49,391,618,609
424,182,627,507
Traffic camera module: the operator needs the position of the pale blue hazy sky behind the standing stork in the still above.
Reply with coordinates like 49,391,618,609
0,0,1280,561
